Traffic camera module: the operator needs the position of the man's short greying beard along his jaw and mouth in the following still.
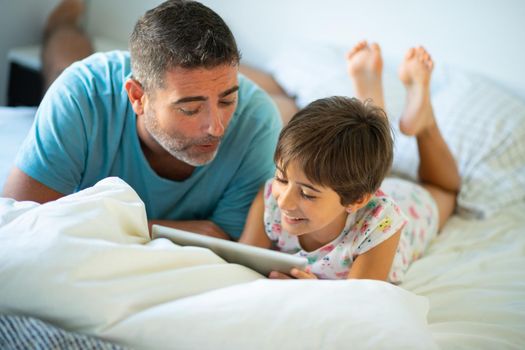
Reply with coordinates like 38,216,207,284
144,108,221,166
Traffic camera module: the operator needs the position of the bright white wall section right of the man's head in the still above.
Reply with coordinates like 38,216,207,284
204,0,525,99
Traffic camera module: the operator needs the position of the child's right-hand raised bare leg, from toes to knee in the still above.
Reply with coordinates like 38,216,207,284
399,47,460,228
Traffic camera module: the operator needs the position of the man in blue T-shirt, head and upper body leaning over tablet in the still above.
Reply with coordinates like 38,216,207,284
3,0,281,238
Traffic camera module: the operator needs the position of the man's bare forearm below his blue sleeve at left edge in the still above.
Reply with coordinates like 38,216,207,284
2,167,64,203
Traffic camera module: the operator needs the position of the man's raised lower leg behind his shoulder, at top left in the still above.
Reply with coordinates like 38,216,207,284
42,0,93,90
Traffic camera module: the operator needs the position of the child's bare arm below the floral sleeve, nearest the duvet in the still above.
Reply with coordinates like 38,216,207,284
348,229,402,281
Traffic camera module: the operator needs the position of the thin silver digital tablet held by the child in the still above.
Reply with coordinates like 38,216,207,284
151,225,308,276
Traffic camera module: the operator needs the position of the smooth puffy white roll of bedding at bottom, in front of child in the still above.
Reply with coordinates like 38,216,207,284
104,280,437,350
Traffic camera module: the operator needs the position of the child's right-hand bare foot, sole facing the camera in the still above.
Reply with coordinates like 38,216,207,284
399,46,436,136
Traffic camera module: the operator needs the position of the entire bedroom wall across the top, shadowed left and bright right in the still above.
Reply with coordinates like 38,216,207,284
0,0,525,105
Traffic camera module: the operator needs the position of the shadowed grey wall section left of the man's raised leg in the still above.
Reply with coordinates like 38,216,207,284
0,0,58,106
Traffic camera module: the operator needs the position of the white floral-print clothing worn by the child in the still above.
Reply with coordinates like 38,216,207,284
264,179,437,283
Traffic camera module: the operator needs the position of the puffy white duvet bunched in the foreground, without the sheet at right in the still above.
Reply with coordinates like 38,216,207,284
0,179,435,349
